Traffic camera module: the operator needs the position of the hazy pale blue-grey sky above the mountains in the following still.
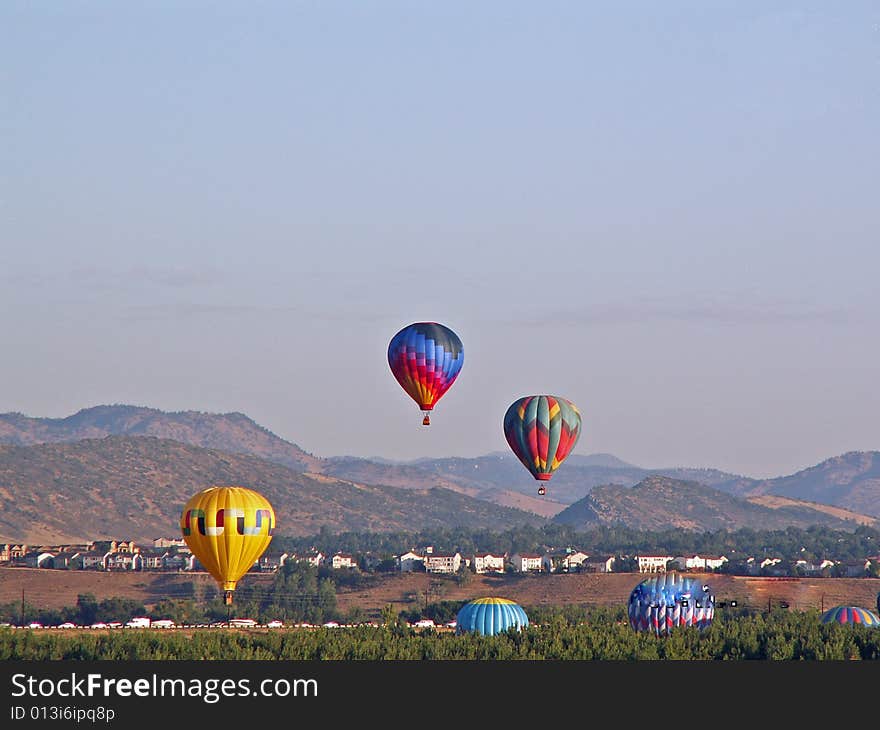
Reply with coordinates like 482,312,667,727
0,0,880,476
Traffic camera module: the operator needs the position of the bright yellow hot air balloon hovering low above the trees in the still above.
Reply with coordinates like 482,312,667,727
180,487,275,606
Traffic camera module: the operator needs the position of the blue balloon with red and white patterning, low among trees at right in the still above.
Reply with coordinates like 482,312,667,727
627,572,715,636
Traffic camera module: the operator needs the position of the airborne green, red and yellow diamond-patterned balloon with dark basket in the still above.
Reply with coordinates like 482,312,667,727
504,395,581,495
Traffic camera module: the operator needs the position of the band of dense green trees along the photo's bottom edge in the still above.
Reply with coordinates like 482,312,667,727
0,607,880,661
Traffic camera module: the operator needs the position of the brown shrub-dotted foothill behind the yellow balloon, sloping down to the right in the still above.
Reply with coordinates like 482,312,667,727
0,436,544,544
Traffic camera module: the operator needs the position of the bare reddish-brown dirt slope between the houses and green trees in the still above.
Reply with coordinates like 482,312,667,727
0,568,880,616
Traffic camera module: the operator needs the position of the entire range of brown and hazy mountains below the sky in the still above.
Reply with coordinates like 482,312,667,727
0,405,880,543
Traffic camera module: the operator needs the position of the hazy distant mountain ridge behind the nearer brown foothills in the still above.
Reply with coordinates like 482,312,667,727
0,404,880,523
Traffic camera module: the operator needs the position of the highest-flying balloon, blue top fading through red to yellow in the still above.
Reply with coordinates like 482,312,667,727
388,322,464,426
